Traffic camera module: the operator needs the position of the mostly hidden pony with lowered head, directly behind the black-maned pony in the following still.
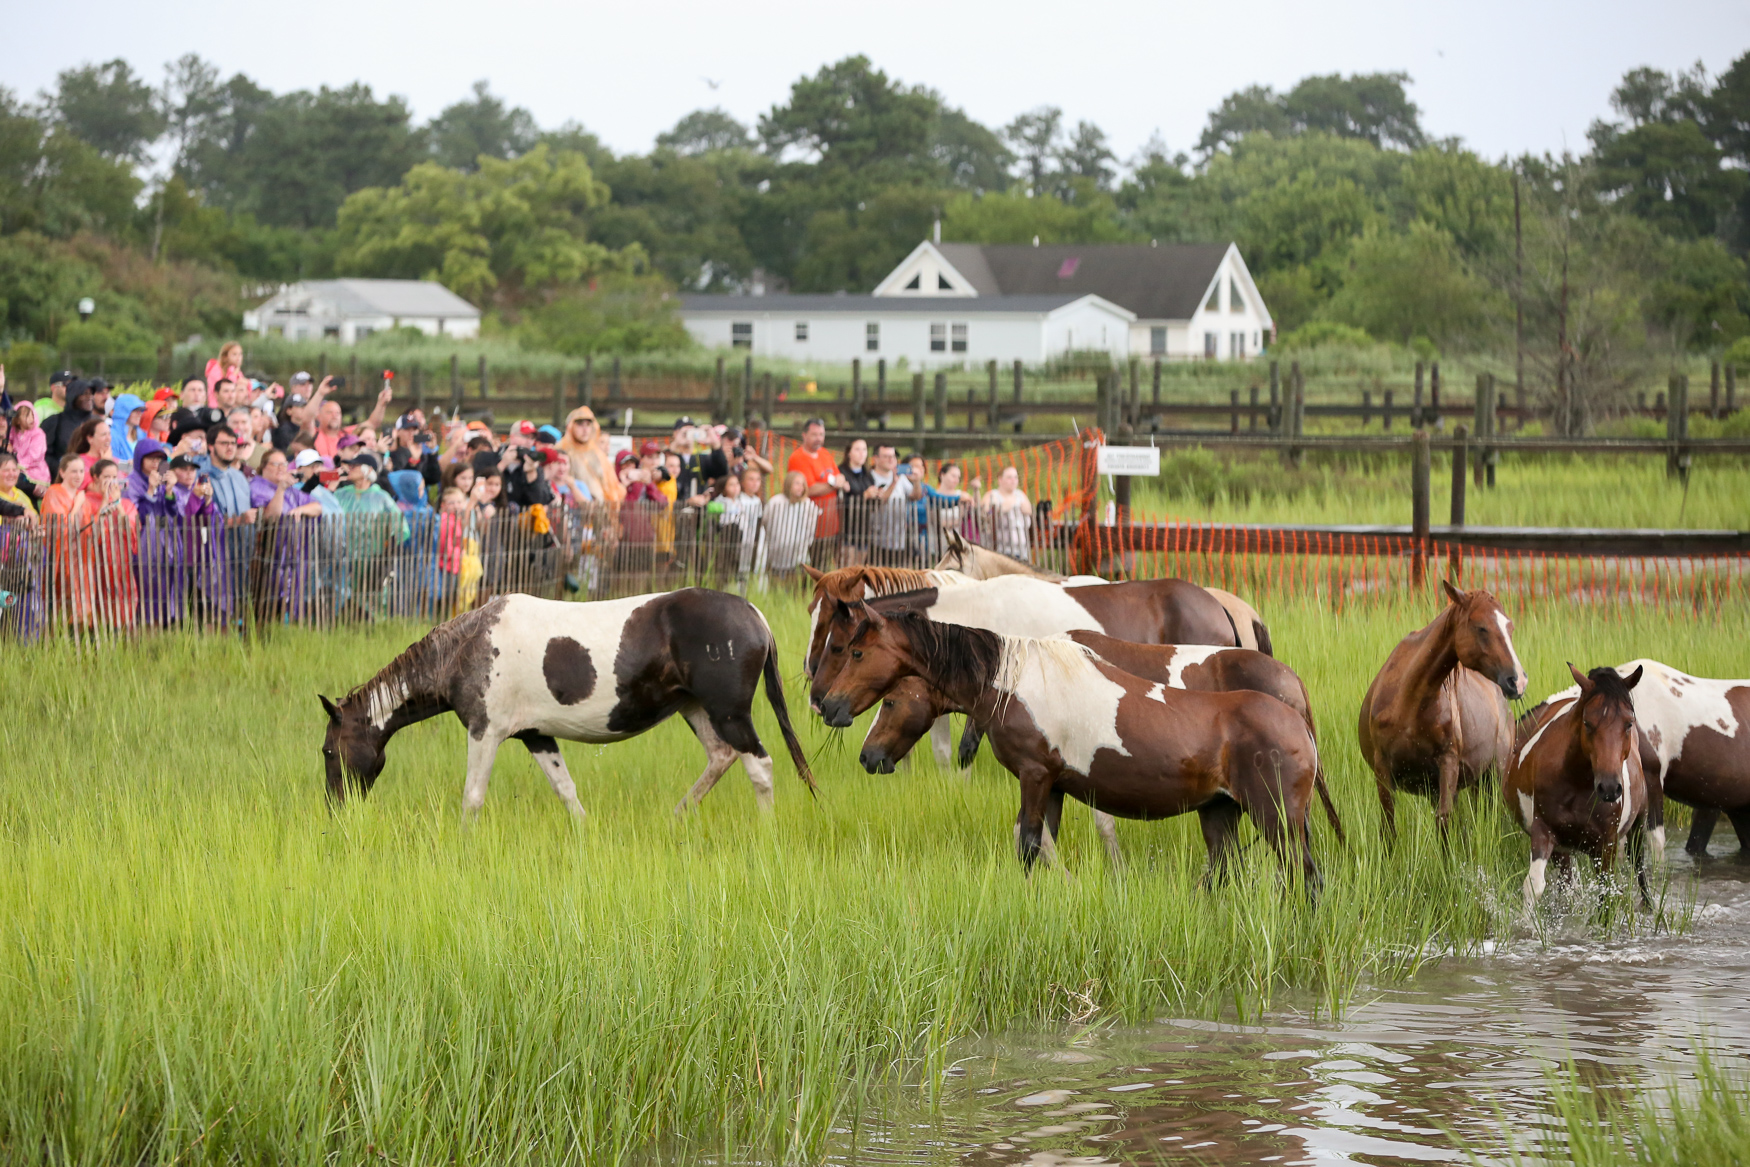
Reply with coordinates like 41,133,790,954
858,632,1344,864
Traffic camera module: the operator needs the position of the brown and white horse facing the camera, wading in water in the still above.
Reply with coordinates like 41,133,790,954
1502,665,1652,908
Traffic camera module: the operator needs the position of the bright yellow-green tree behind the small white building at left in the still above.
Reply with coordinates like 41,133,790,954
334,145,641,308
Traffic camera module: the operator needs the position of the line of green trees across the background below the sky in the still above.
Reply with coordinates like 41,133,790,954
0,54,1750,425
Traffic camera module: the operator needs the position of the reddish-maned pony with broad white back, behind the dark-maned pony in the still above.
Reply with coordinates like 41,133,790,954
803,567,1237,766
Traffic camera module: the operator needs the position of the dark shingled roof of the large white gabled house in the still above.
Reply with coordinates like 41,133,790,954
936,243,1229,320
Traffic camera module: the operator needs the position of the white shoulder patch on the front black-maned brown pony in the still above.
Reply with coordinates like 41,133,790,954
996,640,1131,773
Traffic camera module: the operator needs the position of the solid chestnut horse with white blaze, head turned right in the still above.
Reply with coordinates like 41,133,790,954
1358,583,1526,843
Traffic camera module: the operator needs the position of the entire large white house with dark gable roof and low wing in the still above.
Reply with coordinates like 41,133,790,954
681,240,1274,367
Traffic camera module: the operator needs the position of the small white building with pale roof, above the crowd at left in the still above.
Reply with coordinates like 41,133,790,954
243,280,480,345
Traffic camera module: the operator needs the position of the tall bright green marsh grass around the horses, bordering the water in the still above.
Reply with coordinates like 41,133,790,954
0,595,1750,1165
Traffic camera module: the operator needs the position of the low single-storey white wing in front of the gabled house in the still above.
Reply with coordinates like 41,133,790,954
681,292,1136,367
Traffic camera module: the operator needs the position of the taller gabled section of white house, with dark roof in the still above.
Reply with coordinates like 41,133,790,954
875,241,1274,360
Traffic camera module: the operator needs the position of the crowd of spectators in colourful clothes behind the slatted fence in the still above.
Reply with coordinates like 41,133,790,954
0,345,1034,629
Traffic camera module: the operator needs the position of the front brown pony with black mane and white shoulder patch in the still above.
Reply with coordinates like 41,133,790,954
812,602,1318,894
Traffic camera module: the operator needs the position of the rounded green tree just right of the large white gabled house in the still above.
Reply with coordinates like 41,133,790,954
1321,220,1500,348
